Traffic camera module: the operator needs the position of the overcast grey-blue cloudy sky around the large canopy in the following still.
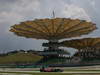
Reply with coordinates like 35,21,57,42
0,0,100,52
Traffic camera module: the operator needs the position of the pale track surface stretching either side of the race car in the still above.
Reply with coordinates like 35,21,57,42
0,66,100,75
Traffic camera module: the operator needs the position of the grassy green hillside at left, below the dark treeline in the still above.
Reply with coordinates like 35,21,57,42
0,53,42,64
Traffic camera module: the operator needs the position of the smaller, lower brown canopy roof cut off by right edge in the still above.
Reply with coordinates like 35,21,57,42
61,38,100,50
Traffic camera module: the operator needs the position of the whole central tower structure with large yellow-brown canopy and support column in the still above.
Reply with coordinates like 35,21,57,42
10,14,96,64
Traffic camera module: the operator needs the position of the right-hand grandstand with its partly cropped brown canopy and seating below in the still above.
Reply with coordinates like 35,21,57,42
60,38,100,61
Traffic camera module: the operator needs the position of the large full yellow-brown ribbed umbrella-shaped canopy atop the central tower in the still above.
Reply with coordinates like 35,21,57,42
10,18,96,40
